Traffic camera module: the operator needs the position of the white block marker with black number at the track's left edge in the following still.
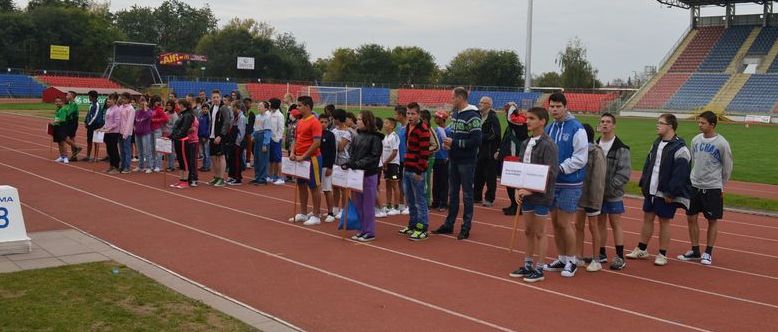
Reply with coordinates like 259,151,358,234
0,186,32,255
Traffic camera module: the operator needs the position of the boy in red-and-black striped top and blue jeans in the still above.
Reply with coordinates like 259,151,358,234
399,107,432,241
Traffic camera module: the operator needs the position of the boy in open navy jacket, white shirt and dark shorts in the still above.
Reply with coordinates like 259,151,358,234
627,114,691,266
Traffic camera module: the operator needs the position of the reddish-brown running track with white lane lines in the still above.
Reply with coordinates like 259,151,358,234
0,114,778,331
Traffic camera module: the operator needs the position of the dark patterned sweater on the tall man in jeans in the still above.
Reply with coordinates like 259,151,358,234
448,105,482,164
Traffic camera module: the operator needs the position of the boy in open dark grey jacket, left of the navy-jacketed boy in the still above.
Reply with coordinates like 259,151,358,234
597,113,632,270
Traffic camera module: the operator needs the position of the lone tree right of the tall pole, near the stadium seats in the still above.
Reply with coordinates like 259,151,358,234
556,37,602,89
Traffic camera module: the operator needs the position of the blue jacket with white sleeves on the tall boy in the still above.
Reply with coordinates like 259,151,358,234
546,114,589,187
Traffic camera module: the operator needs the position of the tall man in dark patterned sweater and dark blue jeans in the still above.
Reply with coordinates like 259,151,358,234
433,87,481,240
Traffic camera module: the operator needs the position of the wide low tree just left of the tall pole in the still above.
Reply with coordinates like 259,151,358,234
442,48,524,86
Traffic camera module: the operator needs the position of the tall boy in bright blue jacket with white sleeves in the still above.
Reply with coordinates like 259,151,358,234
543,92,589,278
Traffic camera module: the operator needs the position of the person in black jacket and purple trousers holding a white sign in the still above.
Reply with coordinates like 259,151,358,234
344,111,384,242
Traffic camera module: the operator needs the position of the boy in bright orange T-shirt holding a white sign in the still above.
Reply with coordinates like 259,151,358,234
289,96,322,226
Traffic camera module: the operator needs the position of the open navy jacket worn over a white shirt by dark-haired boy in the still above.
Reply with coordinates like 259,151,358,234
640,136,692,209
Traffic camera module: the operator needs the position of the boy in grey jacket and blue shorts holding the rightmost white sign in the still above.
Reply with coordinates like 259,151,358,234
509,107,559,282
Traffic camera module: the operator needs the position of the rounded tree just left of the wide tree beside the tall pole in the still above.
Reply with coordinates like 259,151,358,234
392,46,438,84
